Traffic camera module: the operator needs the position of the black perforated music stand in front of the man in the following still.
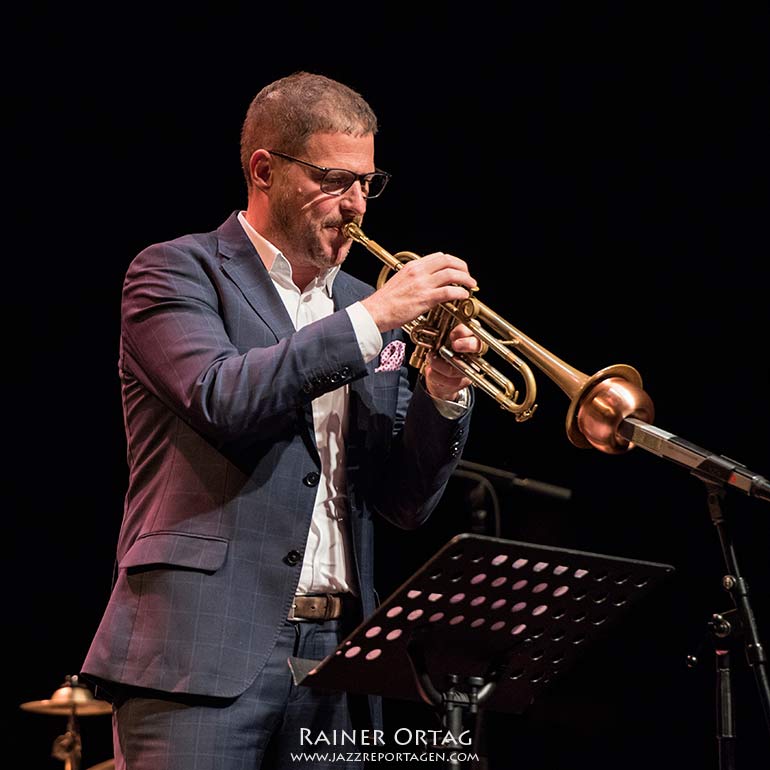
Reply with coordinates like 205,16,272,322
289,533,674,768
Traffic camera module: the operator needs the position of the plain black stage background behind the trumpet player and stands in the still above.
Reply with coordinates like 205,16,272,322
3,3,770,770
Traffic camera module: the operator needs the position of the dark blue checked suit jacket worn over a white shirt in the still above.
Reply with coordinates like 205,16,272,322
82,214,470,696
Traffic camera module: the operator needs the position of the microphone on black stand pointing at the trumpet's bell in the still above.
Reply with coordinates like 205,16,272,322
618,417,770,770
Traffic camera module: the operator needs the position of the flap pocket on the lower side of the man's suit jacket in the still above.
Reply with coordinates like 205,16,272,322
120,532,228,573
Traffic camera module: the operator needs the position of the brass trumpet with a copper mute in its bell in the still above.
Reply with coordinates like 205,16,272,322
343,222,655,454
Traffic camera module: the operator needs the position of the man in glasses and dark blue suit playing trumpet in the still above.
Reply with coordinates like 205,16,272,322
82,73,478,770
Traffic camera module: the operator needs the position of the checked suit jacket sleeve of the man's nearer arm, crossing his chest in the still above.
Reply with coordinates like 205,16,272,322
121,236,366,444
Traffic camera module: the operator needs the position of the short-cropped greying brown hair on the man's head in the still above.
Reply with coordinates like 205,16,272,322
241,71,378,188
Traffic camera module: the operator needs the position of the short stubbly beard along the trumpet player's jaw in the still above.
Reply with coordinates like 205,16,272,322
270,184,351,271
